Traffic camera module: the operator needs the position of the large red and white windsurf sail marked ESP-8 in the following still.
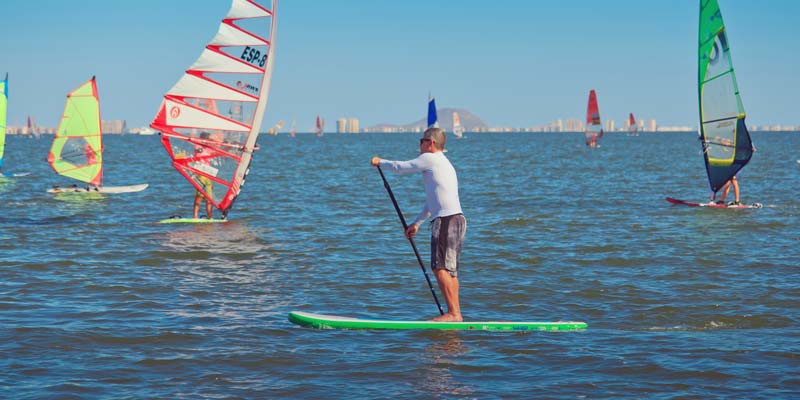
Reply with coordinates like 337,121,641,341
150,0,277,216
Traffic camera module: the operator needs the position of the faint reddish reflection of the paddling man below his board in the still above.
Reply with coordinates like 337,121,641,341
420,331,475,398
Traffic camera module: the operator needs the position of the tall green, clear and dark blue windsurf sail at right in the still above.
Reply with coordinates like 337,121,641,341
697,0,753,193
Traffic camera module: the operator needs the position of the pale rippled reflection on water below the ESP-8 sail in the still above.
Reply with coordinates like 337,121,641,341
158,221,291,329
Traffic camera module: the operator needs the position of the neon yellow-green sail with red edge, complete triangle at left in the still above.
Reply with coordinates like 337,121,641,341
47,77,103,186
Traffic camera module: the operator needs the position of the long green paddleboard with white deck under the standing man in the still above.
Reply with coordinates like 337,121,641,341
289,311,588,331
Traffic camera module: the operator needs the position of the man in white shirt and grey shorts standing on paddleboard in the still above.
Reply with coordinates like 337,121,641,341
370,128,467,322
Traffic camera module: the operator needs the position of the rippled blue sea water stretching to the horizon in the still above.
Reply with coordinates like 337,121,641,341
0,132,800,399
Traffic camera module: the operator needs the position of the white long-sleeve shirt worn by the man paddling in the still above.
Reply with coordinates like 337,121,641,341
380,151,462,226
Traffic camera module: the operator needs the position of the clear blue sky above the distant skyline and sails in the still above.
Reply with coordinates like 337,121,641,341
0,0,800,131
